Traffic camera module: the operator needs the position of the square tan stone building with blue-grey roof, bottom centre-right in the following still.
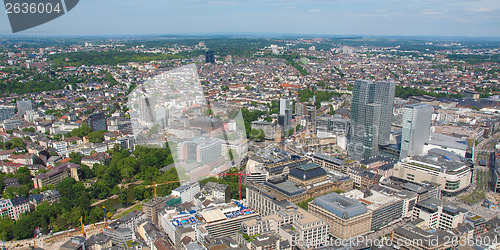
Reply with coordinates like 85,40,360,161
308,193,372,239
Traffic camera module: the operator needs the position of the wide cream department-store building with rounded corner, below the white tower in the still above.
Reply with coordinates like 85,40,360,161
394,149,472,196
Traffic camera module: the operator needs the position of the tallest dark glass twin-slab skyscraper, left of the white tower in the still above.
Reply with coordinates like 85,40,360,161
348,80,395,160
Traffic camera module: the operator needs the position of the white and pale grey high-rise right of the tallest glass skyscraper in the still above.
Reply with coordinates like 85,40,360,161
399,103,434,159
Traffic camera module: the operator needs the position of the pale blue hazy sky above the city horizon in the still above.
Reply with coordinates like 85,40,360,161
0,0,500,37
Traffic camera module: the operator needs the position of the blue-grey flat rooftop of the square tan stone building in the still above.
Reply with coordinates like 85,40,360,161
313,193,367,219
